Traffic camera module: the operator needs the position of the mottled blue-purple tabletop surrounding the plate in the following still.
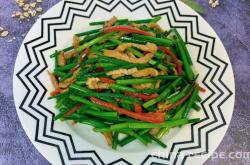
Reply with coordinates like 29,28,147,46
0,0,250,165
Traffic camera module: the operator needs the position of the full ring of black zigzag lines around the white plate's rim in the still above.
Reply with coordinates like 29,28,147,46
17,0,232,164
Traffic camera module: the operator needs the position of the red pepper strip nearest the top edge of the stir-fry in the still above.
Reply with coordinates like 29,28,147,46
103,25,152,36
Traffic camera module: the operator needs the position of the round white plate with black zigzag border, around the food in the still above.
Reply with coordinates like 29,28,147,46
13,0,234,165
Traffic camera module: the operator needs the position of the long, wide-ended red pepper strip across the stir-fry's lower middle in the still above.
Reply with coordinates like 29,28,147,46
89,97,165,123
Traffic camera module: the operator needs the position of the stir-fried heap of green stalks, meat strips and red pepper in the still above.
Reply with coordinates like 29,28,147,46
49,16,205,149
